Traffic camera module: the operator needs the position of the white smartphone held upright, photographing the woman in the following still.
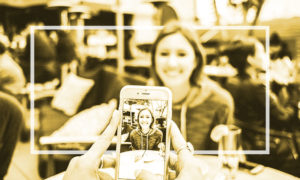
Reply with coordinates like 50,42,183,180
115,86,172,179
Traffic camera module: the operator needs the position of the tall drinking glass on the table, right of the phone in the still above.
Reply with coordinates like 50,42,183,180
218,125,242,179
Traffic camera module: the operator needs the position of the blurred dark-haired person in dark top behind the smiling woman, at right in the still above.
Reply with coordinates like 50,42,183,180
222,37,266,127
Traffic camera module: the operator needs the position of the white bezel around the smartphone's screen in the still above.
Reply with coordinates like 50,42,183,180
115,85,172,180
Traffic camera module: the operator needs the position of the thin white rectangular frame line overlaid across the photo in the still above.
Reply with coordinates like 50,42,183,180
30,26,270,155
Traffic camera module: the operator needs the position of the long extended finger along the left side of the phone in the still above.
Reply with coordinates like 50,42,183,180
83,110,120,168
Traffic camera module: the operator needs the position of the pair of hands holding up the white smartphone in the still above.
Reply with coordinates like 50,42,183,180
63,111,203,180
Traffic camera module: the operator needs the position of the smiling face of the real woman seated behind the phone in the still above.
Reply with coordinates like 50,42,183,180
155,33,196,86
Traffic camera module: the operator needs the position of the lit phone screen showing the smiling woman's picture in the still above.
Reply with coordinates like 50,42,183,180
118,98,169,179
